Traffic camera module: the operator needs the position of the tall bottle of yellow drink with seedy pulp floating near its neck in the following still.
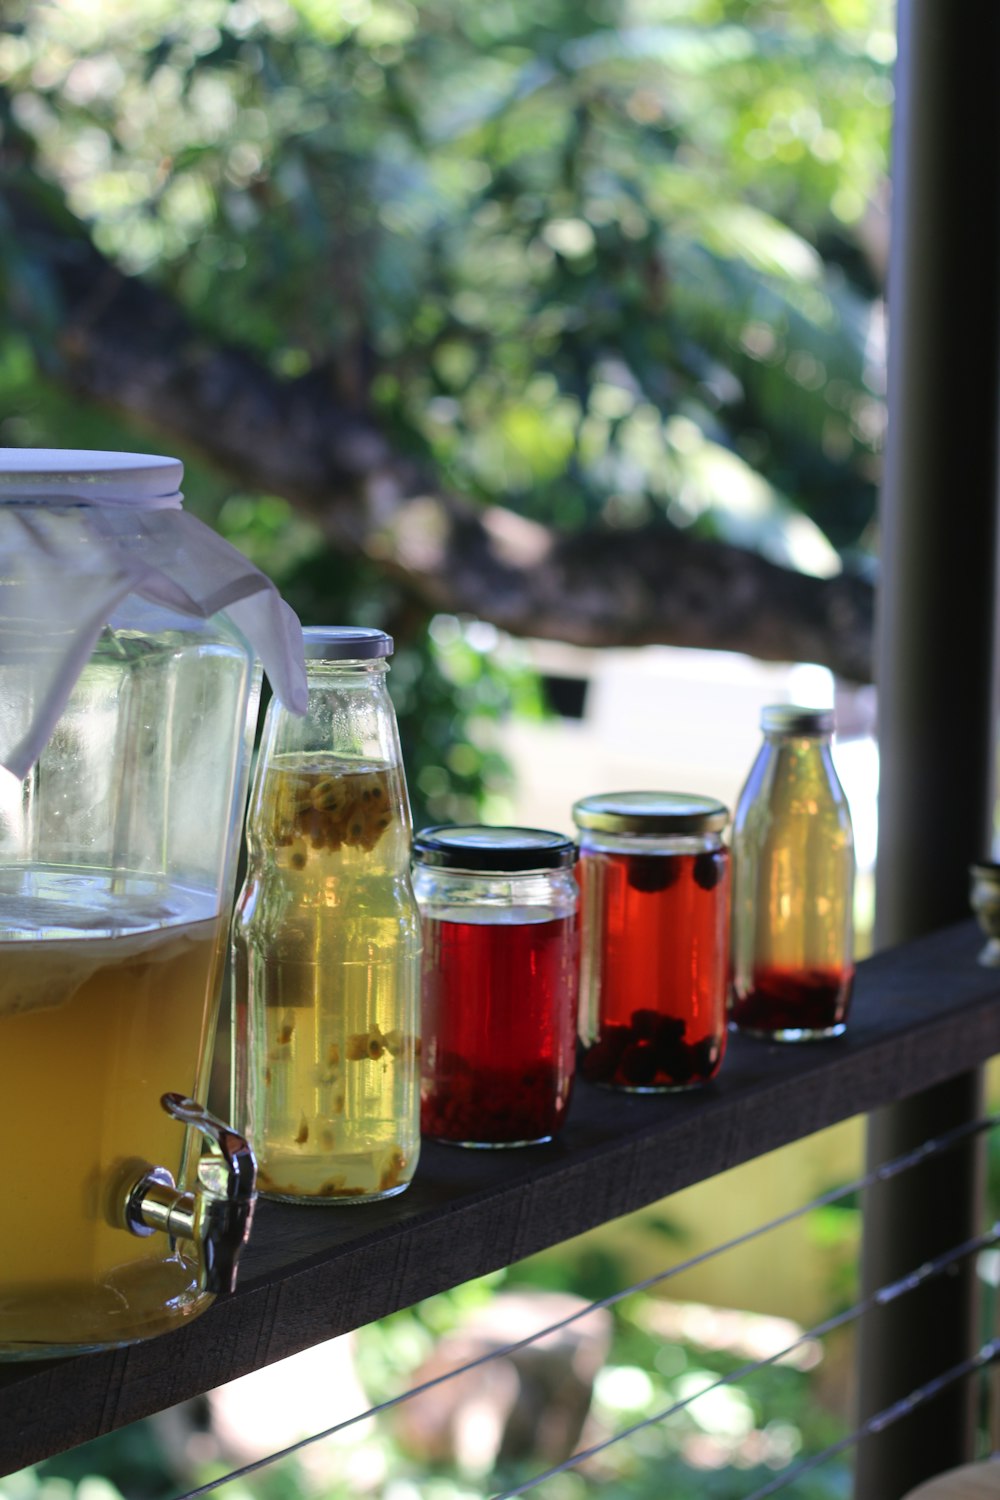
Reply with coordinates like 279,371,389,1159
232,627,420,1203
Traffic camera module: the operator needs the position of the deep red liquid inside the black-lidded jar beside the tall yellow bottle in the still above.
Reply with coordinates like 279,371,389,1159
420,917,577,1145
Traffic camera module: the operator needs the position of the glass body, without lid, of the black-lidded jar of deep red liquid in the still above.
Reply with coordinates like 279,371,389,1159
414,864,577,1148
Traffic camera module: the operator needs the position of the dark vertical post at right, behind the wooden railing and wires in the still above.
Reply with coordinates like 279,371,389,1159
855,0,1000,1500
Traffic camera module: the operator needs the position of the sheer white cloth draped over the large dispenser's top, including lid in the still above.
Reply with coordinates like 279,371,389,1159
0,449,307,779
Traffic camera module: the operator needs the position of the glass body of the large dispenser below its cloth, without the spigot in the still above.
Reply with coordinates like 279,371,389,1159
0,597,259,1358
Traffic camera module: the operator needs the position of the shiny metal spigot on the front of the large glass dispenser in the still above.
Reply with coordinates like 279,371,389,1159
124,1094,256,1293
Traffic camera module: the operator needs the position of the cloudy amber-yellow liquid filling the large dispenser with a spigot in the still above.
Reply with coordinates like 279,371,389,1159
0,870,225,1358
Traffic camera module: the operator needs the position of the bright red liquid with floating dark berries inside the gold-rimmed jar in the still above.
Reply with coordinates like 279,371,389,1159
577,849,729,1089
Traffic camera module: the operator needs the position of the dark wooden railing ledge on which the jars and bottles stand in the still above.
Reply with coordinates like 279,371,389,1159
0,923,1000,1473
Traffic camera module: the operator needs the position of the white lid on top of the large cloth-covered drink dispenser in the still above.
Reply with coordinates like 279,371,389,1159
0,449,184,510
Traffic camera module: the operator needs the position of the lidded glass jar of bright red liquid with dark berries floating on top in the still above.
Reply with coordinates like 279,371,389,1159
573,792,729,1094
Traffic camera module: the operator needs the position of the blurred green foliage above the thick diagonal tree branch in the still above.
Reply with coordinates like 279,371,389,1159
0,0,892,570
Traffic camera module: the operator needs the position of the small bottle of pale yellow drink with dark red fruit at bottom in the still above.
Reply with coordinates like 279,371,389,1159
730,704,855,1041
